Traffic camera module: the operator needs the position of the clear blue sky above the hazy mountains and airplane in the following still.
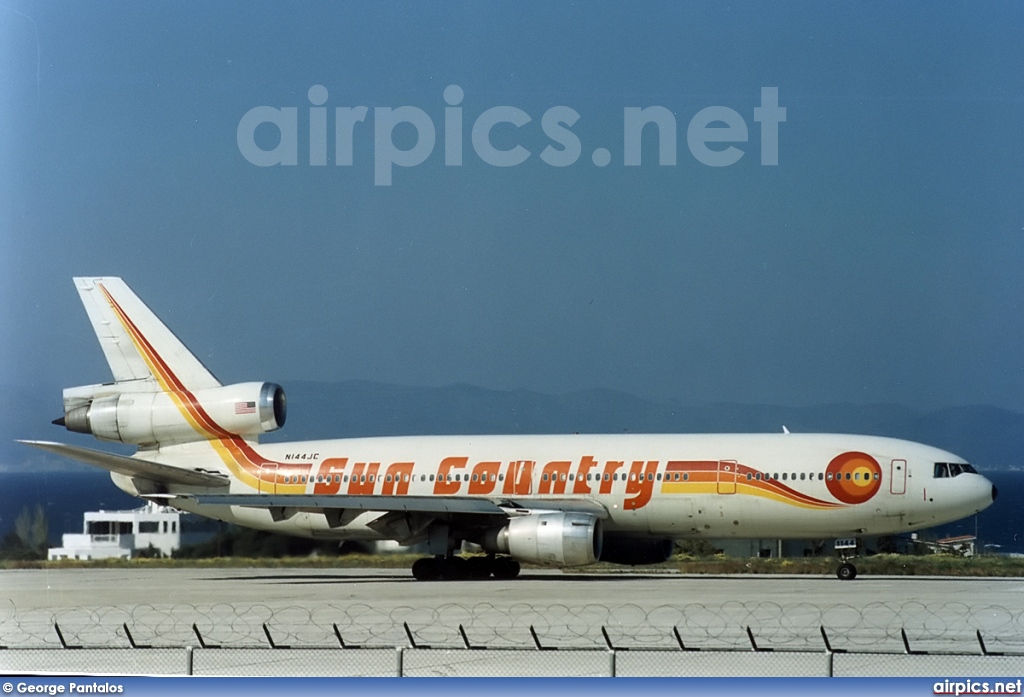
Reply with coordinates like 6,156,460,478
0,0,1024,410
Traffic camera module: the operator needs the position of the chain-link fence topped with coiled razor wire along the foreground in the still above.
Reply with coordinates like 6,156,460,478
0,602,1024,677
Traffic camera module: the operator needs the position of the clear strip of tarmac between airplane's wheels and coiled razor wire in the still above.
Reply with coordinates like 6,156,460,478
0,568,1024,611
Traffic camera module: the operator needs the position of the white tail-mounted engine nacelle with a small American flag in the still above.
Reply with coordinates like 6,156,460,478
57,383,288,445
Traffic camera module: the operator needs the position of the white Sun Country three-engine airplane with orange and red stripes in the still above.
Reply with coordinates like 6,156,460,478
22,277,997,580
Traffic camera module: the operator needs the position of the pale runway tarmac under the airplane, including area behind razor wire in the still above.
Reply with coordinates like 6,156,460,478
6,568,1024,654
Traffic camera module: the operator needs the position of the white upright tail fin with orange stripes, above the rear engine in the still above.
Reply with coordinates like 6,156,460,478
75,276,220,392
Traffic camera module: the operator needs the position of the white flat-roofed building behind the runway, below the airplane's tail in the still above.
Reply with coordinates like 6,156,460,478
47,503,181,560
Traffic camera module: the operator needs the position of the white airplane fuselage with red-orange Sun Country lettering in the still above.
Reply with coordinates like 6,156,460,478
115,434,993,539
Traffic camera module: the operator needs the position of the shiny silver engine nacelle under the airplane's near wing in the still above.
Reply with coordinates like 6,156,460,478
484,512,603,566
